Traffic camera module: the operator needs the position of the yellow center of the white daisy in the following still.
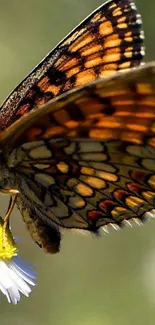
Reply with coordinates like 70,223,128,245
0,217,17,261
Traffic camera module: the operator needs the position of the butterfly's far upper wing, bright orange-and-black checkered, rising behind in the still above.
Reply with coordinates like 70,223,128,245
0,0,144,130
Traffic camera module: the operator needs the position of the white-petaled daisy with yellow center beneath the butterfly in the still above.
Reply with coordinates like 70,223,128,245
0,218,36,305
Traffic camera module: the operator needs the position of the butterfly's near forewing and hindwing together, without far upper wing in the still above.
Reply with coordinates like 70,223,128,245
4,63,155,233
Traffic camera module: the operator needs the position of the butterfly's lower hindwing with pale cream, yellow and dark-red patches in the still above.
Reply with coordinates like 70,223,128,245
9,140,155,233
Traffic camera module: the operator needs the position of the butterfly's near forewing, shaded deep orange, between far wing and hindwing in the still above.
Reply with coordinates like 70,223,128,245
0,64,155,150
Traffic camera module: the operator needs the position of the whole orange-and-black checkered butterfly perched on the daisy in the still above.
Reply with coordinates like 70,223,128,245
0,0,155,253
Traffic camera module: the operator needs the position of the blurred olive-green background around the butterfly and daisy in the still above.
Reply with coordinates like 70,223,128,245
0,0,155,325
